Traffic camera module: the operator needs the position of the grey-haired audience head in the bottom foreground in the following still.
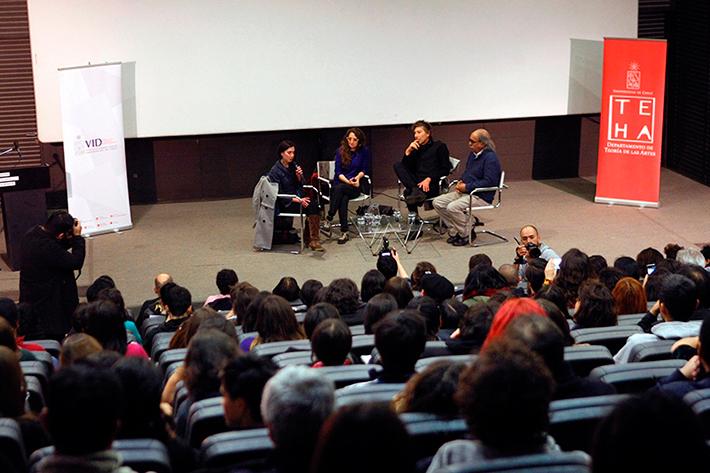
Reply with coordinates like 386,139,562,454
261,366,335,471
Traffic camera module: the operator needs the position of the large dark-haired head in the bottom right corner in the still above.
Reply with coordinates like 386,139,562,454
591,389,708,473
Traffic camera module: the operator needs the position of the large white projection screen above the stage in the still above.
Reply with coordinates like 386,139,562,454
28,0,638,142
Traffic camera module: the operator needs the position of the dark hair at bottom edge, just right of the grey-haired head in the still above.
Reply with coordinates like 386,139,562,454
311,404,416,473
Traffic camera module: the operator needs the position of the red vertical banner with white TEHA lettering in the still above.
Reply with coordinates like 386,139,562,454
594,38,666,207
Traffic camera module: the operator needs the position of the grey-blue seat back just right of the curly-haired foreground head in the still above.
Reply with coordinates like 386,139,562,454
548,394,629,453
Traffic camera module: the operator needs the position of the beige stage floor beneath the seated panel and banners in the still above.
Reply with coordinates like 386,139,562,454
0,169,710,306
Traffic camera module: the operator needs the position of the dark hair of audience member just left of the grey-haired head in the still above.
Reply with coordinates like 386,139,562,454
220,353,279,424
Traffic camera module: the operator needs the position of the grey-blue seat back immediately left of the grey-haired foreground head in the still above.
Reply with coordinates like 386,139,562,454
200,429,274,471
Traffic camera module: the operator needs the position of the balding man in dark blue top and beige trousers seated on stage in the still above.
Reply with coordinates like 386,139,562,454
434,128,501,246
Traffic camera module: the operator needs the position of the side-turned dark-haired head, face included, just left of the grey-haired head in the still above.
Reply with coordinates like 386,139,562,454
220,353,279,429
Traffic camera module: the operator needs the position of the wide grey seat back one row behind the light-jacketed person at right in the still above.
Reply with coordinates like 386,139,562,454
589,360,685,394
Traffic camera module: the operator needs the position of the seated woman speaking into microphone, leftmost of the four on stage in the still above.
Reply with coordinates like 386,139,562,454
267,140,323,251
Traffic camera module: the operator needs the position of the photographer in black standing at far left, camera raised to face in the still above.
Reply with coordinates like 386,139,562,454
20,210,86,342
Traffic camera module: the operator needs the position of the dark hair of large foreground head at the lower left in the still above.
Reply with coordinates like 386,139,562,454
47,364,123,455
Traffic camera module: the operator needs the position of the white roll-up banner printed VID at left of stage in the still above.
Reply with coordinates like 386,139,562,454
59,63,133,236
